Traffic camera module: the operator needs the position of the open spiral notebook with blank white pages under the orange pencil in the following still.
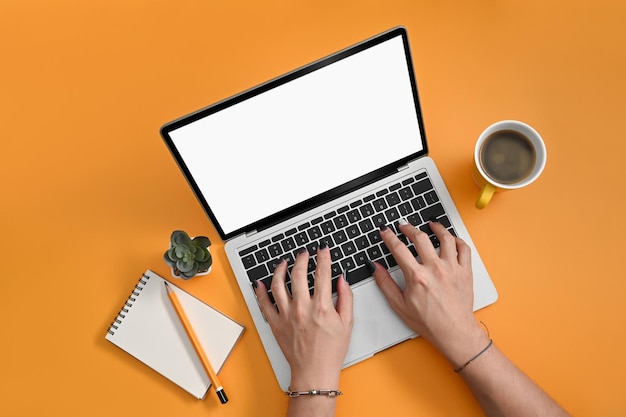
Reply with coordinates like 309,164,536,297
105,270,244,399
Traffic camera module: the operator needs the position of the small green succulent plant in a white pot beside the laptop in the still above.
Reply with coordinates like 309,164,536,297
163,230,213,279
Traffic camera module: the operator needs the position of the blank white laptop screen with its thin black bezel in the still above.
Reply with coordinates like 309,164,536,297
162,28,426,239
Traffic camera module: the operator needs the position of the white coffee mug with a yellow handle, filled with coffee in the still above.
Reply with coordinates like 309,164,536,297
473,120,547,209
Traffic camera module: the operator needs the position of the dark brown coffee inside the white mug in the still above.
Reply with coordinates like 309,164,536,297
480,130,535,184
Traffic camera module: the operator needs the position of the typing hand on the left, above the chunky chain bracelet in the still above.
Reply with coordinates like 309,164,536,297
256,245,353,391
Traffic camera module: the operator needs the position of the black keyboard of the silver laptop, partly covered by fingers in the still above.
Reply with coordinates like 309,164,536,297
239,172,456,302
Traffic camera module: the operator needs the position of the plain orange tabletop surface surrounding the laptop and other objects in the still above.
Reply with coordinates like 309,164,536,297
0,0,626,417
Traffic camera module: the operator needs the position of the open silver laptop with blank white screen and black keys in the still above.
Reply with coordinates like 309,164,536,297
161,27,498,390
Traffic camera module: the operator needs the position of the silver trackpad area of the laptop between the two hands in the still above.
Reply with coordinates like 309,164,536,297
344,271,416,366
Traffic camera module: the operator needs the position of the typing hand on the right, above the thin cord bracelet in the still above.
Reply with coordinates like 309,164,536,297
374,220,488,366
